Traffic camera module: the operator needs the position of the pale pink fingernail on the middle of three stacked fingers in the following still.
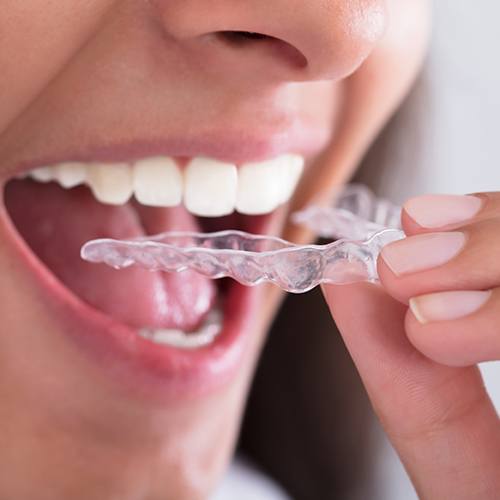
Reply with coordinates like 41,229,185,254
381,232,465,276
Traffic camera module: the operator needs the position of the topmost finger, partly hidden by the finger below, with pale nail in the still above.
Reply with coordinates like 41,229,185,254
401,192,500,236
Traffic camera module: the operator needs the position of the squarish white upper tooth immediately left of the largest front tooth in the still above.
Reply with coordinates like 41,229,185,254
133,157,182,207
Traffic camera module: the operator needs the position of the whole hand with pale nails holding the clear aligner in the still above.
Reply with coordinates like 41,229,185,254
323,193,500,500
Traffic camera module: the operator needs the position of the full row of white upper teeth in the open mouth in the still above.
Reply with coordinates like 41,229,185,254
28,154,304,217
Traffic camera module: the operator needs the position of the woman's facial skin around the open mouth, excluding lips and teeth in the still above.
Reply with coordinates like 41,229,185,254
0,0,428,500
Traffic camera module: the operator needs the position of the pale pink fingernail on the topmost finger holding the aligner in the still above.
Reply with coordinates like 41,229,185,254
404,194,483,228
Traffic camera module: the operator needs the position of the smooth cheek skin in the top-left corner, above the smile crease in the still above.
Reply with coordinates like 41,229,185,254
0,0,112,134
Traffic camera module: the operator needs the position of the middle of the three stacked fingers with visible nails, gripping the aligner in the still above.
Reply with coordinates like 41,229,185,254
378,217,500,303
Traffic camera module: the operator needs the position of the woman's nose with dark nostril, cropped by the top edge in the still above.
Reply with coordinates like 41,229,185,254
150,0,386,81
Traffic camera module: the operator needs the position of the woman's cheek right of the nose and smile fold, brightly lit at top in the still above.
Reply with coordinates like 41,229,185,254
285,0,430,242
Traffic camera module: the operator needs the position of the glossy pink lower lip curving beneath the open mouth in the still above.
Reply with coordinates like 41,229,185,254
0,186,258,400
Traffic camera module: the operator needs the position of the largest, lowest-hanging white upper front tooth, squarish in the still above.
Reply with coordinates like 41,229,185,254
184,158,238,217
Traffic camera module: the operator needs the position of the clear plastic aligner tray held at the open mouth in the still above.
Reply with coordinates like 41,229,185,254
81,185,404,293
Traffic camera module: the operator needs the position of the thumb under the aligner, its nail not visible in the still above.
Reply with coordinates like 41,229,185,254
324,284,500,500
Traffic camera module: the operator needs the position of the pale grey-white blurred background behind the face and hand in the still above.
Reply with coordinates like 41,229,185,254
364,0,500,500
